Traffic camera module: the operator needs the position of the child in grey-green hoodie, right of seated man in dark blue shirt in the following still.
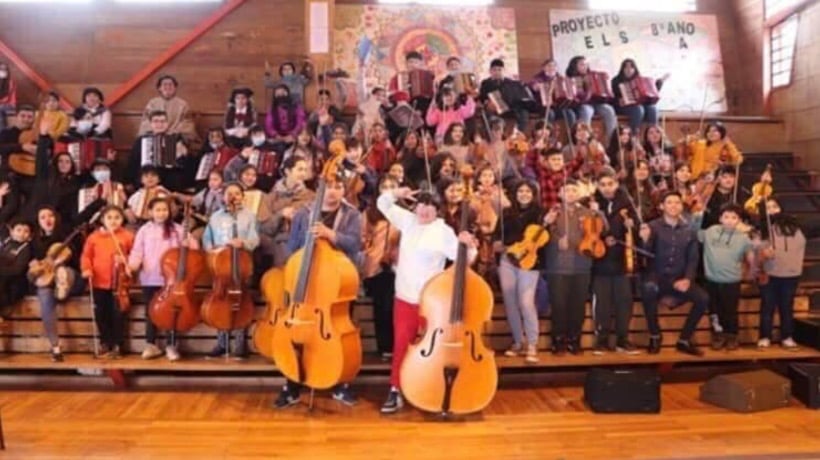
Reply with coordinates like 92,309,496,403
697,204,755,351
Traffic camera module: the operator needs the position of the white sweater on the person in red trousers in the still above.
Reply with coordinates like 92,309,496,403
376,192,476,304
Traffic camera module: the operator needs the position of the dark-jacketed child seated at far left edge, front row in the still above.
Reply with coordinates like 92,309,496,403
0,219,32,322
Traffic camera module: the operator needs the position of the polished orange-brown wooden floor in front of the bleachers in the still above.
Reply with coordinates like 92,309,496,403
0,375,820,460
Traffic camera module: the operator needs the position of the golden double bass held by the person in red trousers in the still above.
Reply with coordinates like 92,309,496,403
400,201,498,416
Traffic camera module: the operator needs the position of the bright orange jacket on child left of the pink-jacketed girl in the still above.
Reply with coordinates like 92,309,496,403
80,228,134,289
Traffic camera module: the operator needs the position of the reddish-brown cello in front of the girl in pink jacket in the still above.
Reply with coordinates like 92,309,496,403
148,203,205,334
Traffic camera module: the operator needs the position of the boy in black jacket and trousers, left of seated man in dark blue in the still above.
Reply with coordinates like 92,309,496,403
592,167,638,355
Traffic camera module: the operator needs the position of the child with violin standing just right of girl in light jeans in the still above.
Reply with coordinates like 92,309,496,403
544,180,605,356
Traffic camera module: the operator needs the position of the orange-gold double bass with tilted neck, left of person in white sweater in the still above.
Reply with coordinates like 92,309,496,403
272,161,362,389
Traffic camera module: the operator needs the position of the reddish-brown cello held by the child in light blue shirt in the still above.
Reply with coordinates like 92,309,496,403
200,203,254,331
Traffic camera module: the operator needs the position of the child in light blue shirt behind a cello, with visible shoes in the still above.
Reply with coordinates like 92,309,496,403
202,183,259,359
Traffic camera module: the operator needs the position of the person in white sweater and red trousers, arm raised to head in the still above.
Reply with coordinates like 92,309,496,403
377,187,476,414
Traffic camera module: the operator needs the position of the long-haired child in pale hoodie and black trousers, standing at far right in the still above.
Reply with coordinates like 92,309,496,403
757,198,806,350
